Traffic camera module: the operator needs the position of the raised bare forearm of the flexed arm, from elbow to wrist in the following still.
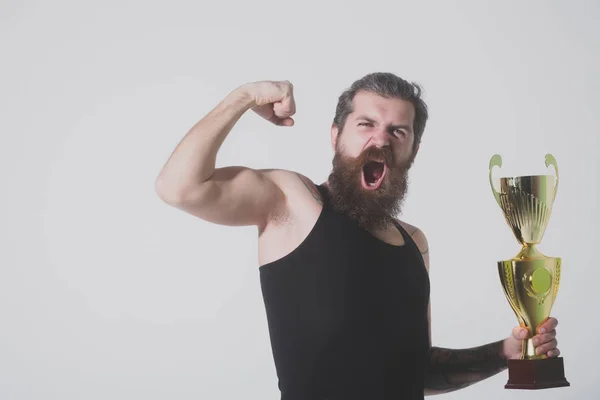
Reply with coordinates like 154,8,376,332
157,87,253,193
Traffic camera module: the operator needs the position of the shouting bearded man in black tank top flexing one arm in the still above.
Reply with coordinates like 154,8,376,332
156,73,560,400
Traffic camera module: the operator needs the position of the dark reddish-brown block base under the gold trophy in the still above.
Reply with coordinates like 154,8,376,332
504,357,571,389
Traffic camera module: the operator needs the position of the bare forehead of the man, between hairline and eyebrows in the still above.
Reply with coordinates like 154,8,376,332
350,91,415,125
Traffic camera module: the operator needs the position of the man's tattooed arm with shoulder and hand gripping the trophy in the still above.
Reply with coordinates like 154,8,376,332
403,223,560,395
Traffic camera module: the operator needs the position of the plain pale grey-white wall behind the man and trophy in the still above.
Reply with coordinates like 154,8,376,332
0,0,600,400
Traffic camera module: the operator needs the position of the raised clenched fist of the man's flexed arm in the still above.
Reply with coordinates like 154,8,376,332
243,81,296,126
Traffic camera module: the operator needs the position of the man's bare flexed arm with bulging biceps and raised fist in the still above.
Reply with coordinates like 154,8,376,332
156,82,295,227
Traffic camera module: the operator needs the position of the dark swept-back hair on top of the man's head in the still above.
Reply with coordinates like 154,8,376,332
333,72,428,148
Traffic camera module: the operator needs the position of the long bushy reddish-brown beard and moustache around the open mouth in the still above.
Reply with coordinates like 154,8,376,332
328,147,412,230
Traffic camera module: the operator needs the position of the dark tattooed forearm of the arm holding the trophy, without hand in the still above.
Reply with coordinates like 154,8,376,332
425,340,507,395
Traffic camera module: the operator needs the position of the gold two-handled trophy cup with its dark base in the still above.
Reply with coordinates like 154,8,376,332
489,154,570,389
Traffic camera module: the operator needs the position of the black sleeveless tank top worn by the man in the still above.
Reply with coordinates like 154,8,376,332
259,186,430,400
